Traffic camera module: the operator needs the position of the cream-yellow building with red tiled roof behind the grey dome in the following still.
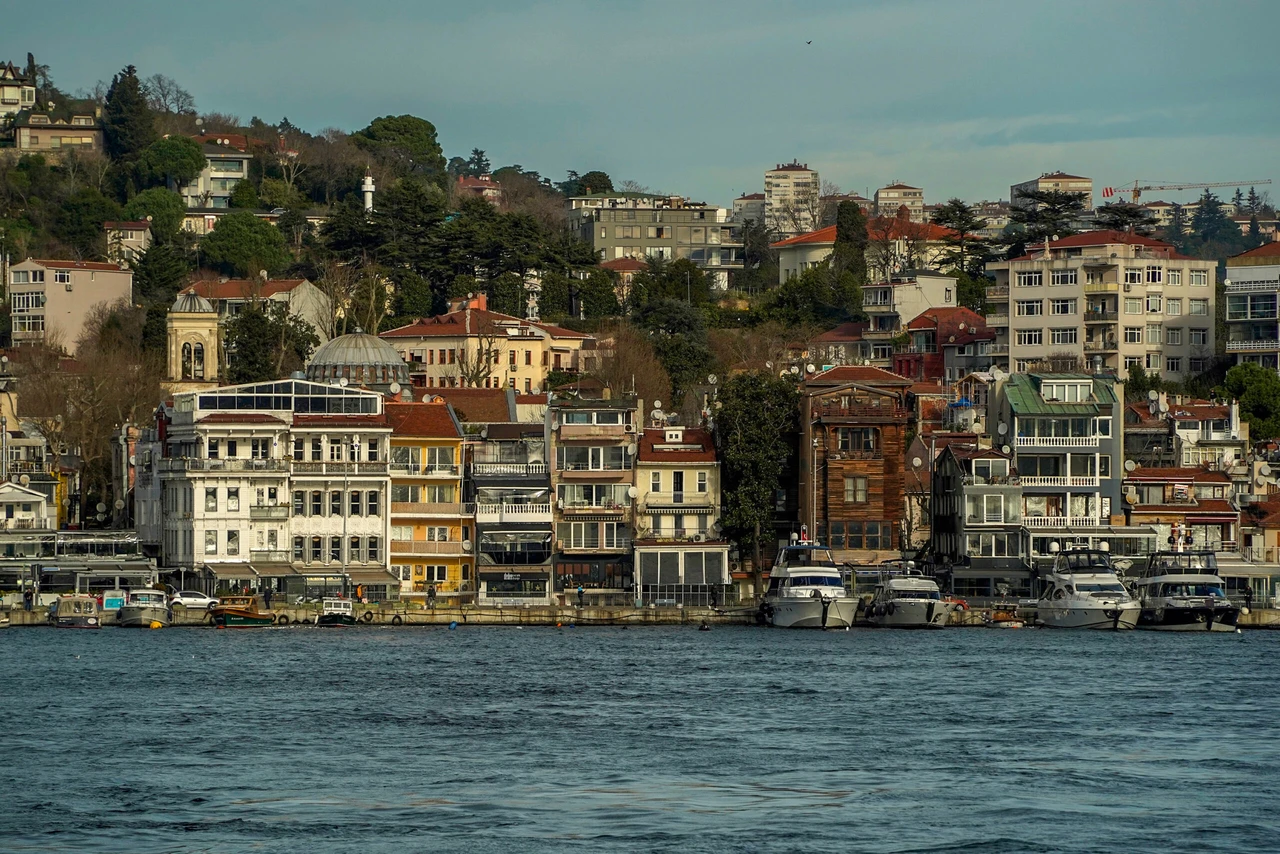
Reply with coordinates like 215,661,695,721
380,293,595,393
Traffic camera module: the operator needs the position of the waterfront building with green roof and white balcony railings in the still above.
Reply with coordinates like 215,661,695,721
987,373,1129,557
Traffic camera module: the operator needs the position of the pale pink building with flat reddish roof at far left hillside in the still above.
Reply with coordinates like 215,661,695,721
9,259,133,356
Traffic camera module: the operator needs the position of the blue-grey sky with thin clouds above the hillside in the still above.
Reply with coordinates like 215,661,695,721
12,0,1280,205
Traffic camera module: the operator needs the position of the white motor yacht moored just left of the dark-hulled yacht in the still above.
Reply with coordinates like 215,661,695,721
1036,548,1142,630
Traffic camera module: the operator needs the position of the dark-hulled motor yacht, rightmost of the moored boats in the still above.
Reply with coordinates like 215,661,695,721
1134,552,1240,631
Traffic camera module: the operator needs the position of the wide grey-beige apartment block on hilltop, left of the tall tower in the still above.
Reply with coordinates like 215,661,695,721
570,196,744,289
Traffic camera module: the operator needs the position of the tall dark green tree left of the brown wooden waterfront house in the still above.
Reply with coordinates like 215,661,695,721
714,371,799,593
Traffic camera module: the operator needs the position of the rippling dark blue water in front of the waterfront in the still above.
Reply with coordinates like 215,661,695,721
0,627,1280,854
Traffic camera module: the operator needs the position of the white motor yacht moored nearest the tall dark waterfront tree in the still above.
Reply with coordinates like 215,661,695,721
759,543,858,629
